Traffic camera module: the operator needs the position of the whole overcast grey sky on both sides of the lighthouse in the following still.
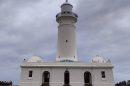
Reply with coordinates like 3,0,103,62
0,0,130,84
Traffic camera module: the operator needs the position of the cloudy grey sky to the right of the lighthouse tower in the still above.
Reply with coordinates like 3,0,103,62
76,0,130,81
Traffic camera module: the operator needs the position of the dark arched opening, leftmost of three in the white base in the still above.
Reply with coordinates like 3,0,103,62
42,71,50,86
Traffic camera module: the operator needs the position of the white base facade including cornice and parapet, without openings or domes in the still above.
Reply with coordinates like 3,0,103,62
20,62,114,86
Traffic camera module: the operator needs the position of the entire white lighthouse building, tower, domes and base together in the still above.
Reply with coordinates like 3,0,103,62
20,0,114,86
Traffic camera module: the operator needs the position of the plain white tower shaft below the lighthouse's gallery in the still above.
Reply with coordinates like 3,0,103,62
56,18,77,61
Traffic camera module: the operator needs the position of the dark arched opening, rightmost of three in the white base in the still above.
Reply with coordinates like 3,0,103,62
84,71,92,86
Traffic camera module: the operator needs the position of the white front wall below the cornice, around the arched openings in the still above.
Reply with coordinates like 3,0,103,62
20,67,114,86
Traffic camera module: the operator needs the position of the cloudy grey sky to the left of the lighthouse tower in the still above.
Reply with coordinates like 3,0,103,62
0,0,57,84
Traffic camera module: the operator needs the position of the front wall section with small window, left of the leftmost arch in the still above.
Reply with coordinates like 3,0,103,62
20,68,42,86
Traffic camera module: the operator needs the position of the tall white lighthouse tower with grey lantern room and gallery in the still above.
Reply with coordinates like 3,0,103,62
56,0,78,61
